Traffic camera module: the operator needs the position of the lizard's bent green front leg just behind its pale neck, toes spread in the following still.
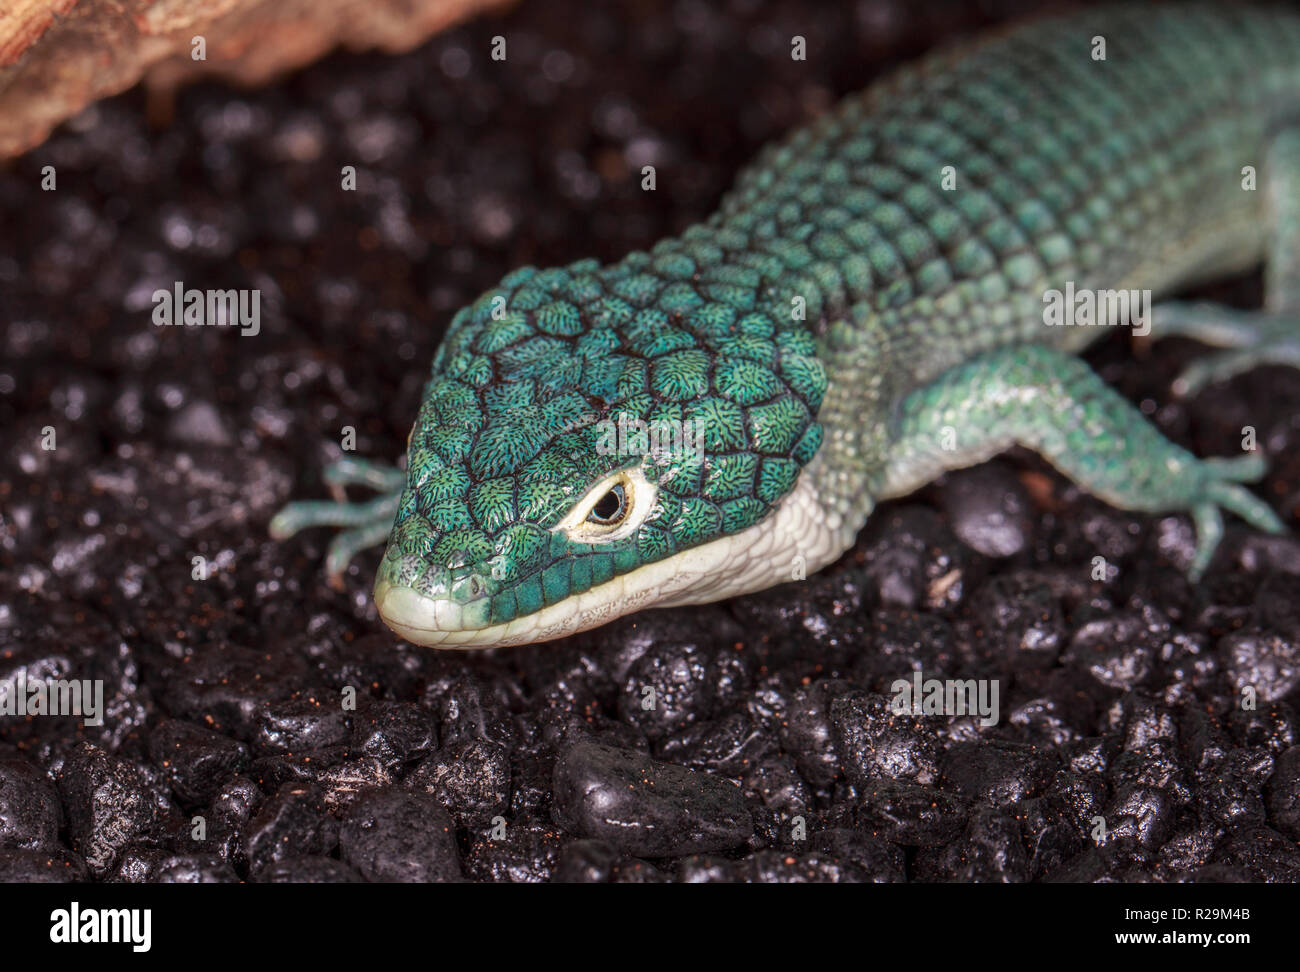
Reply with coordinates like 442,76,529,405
876,346,1286,581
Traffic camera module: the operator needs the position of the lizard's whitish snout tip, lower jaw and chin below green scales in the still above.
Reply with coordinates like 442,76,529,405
374,469,855,648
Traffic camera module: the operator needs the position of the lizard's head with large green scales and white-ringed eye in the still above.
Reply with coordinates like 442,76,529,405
374,255,826,647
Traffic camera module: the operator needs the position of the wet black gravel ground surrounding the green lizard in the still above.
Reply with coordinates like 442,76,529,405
0,0,1300,882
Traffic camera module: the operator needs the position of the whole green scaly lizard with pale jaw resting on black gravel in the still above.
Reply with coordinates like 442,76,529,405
272,5,1300,647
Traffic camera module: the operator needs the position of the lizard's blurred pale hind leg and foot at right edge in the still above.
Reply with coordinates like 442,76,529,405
1152,127,1300,396
